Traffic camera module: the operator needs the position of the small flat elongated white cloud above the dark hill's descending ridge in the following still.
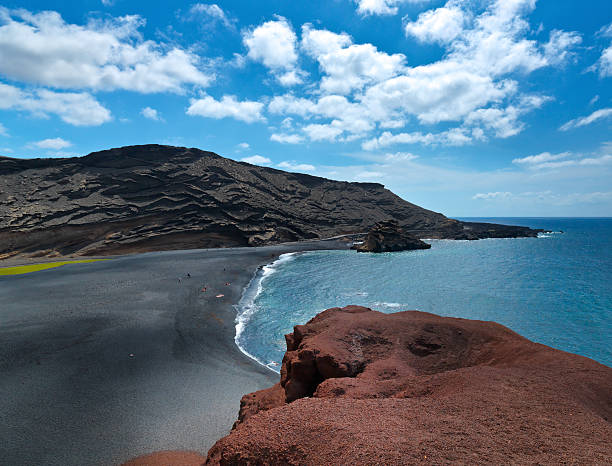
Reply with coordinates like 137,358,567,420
187,95,265,123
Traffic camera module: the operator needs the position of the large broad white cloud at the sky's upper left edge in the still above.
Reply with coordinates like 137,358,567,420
0,9,213,93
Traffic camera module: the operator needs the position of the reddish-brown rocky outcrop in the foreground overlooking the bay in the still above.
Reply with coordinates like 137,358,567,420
207,306,612,465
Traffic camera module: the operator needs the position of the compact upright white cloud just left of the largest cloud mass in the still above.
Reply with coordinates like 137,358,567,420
242,16,304,86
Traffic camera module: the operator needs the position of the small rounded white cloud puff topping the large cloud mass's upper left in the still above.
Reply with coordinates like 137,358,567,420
404,7,467,43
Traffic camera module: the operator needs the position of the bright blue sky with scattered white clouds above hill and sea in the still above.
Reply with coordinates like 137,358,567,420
0,0,612,217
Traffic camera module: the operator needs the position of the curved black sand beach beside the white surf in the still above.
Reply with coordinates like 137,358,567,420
0,241,347,465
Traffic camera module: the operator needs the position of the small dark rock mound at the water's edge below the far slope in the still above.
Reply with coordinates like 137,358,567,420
352,220,431,252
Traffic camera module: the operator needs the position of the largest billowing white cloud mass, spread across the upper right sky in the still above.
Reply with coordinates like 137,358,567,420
268,0,582,148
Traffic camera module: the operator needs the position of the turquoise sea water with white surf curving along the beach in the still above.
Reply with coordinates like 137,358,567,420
236,218,612,370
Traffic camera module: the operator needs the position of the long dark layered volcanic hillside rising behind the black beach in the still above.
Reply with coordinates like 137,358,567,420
0,145,536,258
